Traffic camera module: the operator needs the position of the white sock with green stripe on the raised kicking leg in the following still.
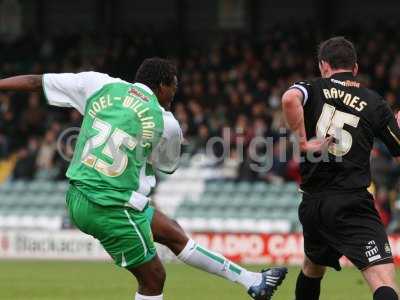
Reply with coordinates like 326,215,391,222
178,239,262,289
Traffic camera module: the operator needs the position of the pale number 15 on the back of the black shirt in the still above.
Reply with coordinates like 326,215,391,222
316,103,360,156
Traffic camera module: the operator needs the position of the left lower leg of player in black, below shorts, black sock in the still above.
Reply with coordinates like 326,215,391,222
295,256,326,300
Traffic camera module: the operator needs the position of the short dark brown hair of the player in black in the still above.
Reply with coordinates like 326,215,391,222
318,36,357,69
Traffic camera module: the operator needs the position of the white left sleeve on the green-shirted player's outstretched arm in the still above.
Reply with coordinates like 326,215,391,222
43,72,122,115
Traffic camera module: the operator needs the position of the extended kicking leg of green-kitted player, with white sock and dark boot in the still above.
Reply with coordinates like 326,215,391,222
151,210,287,299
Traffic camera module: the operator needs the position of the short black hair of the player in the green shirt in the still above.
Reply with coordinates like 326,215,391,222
135,57,177,90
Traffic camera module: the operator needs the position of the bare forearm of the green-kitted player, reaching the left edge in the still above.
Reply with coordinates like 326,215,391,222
0,75,42,92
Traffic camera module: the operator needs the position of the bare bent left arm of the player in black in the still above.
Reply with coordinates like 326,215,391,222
282,89,332,152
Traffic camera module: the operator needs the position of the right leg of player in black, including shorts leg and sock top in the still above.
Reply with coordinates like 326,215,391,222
341,191,398,300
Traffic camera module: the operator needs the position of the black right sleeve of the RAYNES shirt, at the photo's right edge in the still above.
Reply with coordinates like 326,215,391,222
377,101,400,156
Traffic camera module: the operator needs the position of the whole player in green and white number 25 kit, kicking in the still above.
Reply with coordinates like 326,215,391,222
0,58,287,300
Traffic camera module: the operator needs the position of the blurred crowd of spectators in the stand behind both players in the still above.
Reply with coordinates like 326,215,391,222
0,25,400,220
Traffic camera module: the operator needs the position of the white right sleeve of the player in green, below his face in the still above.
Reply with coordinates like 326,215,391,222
150,112,183,174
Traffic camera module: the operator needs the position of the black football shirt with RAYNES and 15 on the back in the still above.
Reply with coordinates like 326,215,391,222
291,72,400,192
